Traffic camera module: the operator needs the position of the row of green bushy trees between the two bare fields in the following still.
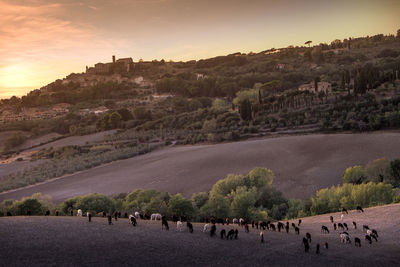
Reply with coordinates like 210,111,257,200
0,163,400,221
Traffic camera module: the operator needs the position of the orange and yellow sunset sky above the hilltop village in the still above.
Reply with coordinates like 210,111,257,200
0,0,400,99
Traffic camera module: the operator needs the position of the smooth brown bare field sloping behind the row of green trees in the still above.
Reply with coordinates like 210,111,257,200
0,132,400,202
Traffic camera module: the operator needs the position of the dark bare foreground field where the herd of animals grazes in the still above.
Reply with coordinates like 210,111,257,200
0,204,400,267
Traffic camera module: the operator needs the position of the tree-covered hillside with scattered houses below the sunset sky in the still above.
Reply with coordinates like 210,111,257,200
0,34,400,154
